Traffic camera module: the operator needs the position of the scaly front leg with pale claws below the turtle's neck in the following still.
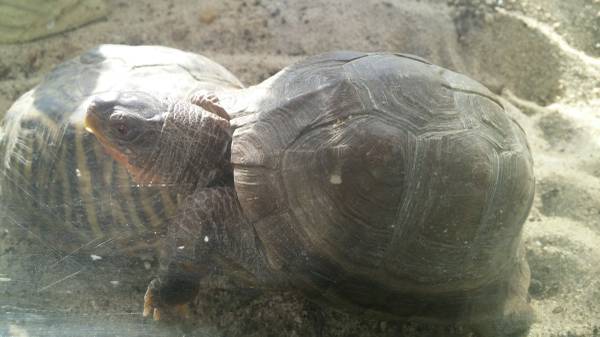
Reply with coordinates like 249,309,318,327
143,186,265,320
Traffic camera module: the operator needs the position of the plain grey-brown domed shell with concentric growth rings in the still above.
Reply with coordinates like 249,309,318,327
232,52,534,319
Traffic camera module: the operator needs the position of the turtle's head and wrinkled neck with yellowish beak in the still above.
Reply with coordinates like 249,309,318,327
85,92,231,189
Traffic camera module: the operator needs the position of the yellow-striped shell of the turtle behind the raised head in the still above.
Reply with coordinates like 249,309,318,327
0,45,242,249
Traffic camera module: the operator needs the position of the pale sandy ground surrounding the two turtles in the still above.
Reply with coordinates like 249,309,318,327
0,0,600,336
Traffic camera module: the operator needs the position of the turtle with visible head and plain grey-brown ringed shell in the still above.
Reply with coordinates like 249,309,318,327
85,51,535,336
